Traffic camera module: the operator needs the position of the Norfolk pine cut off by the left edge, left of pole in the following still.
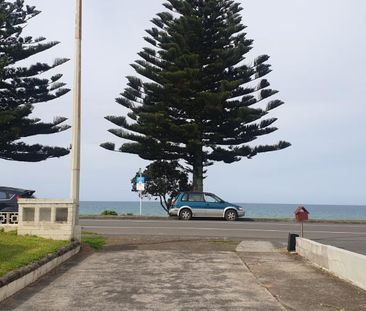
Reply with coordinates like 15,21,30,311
0,0,69,162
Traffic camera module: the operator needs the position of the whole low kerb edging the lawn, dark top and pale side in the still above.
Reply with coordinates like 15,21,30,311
0,242,81,302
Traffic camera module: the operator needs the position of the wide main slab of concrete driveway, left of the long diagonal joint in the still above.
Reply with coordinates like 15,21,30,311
0,250,284,311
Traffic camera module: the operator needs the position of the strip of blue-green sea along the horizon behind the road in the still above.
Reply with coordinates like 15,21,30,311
80,201,366,220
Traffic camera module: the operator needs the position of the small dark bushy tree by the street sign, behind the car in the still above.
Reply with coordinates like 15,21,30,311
131,161,191,213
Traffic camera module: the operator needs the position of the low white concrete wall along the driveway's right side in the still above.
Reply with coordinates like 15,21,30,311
296,238,366,290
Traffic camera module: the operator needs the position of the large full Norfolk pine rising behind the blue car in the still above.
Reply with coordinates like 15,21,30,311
102,0,290,191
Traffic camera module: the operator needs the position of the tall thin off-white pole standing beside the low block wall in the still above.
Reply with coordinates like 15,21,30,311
71,0,82,240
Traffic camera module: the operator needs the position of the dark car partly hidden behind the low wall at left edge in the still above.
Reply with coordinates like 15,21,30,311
0,187,35,212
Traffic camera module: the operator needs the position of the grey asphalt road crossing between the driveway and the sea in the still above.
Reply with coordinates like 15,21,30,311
80,219,366,255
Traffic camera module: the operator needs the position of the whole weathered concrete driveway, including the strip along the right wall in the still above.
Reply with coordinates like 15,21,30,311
0,236,366,311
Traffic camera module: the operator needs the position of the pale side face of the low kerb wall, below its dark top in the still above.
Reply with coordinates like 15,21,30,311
0,246,80,302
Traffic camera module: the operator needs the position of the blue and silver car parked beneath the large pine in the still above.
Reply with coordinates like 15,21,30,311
169,192,245,221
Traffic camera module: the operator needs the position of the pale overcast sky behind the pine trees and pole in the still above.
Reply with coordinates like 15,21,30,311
0,0,366,205
